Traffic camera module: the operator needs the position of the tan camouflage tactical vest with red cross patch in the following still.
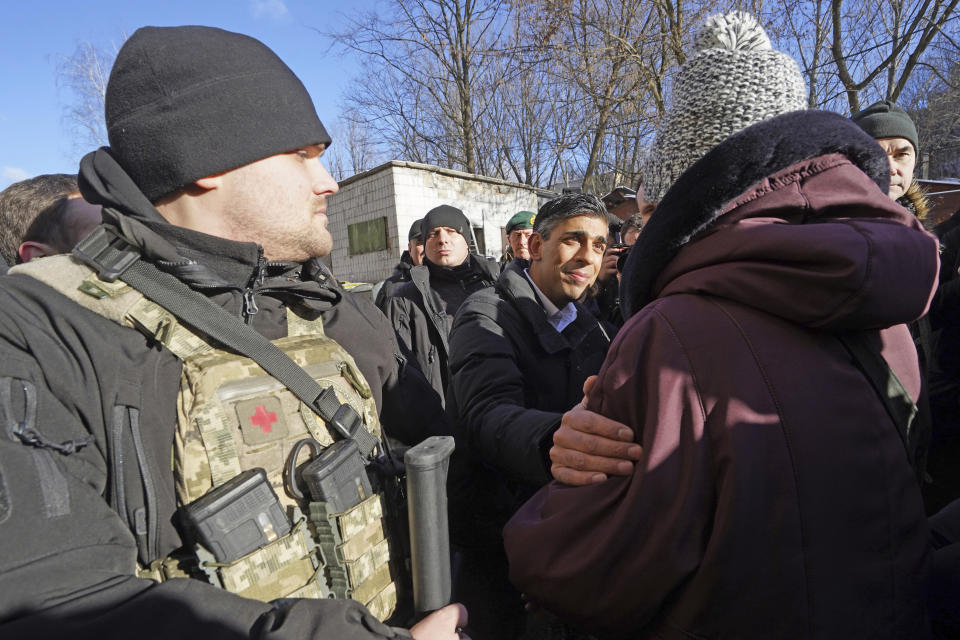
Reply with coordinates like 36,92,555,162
12,256,397,620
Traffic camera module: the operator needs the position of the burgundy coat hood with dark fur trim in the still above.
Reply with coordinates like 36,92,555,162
622,111,937,329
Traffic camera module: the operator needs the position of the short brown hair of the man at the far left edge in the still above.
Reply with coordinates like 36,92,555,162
0,173,78,265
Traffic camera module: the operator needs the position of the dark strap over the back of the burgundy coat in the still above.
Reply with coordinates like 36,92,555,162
837,332,917,464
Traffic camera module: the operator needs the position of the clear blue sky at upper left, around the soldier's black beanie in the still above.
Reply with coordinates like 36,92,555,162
0,0,376,189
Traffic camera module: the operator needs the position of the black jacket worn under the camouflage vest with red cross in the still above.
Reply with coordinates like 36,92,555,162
0,150,447,639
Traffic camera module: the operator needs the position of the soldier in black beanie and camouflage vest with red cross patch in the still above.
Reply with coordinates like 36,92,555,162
0,26,466,640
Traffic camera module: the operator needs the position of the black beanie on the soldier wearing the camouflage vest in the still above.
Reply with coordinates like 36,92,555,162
106,26,330,202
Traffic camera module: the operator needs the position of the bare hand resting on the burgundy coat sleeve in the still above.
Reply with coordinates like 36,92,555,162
550,376,642,485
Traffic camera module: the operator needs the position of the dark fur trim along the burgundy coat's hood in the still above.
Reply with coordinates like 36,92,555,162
621,111,890,317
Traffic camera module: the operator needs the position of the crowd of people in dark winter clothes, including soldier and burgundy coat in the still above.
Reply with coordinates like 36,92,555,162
0,12,960,640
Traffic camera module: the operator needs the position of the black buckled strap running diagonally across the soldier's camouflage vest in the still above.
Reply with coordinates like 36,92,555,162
73,226,378,457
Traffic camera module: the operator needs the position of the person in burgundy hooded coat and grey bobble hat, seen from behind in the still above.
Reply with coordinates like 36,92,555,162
504,14,939,639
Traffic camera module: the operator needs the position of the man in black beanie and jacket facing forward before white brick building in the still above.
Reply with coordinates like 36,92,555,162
383,204,500,400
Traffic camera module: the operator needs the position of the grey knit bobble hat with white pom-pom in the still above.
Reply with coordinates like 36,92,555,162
641,11,807,202
